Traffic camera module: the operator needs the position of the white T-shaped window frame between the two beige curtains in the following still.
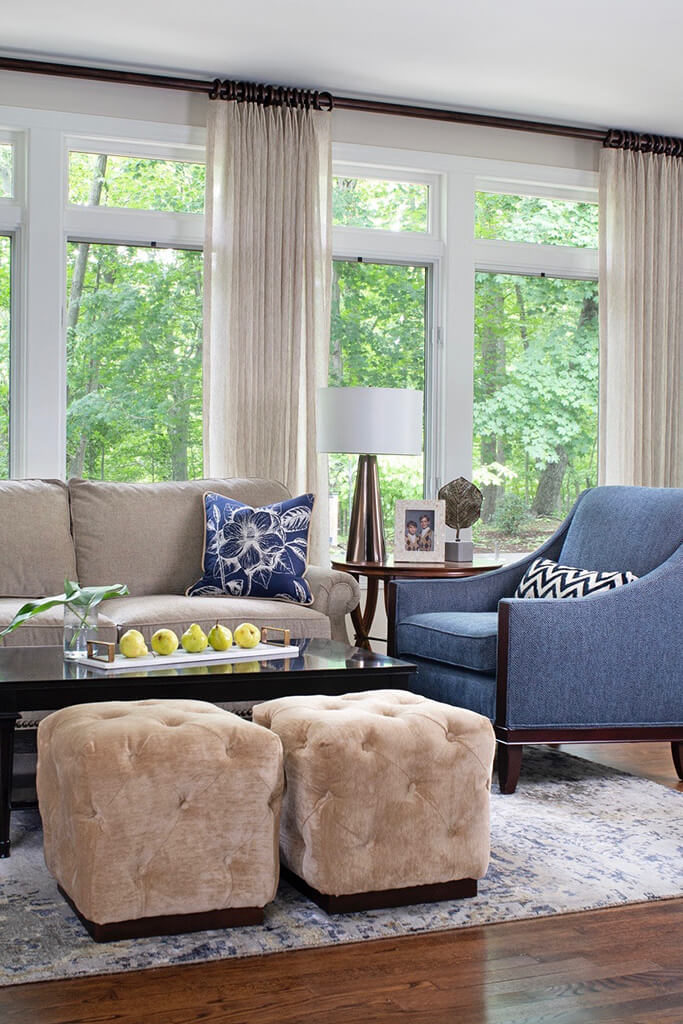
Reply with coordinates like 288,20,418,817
333,142,598,512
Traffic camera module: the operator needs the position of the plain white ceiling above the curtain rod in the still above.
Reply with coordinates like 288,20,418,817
0,0,683,136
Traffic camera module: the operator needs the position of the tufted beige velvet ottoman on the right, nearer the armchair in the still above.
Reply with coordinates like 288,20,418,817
254,690,495,913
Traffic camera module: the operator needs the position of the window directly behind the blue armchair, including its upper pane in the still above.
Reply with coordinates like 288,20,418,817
472,193,598,554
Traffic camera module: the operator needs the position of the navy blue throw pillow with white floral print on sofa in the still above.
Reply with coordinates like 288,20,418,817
186,490,314,604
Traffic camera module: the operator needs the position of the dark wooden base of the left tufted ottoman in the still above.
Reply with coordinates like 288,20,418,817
57,886,263,942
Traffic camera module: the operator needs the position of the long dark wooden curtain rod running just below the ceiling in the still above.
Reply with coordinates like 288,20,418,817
0,56,607,142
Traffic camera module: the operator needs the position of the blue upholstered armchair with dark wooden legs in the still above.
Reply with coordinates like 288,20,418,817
389,486,683,793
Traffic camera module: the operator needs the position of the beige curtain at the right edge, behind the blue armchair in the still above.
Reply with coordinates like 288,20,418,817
600,148,683,486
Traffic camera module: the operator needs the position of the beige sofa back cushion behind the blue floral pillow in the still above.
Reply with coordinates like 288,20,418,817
69,478,290,595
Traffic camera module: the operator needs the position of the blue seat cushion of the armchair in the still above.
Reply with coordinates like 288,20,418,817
396,611,498,672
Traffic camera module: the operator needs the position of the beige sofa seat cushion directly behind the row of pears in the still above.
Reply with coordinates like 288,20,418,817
102,594,330,641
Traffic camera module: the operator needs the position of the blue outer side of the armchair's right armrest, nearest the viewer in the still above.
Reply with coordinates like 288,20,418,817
496,545,683,729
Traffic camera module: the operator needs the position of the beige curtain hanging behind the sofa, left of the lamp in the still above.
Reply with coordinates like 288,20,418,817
204,101,332,564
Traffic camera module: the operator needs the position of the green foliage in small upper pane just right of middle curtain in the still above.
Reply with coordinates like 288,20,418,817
332,175,429,232
